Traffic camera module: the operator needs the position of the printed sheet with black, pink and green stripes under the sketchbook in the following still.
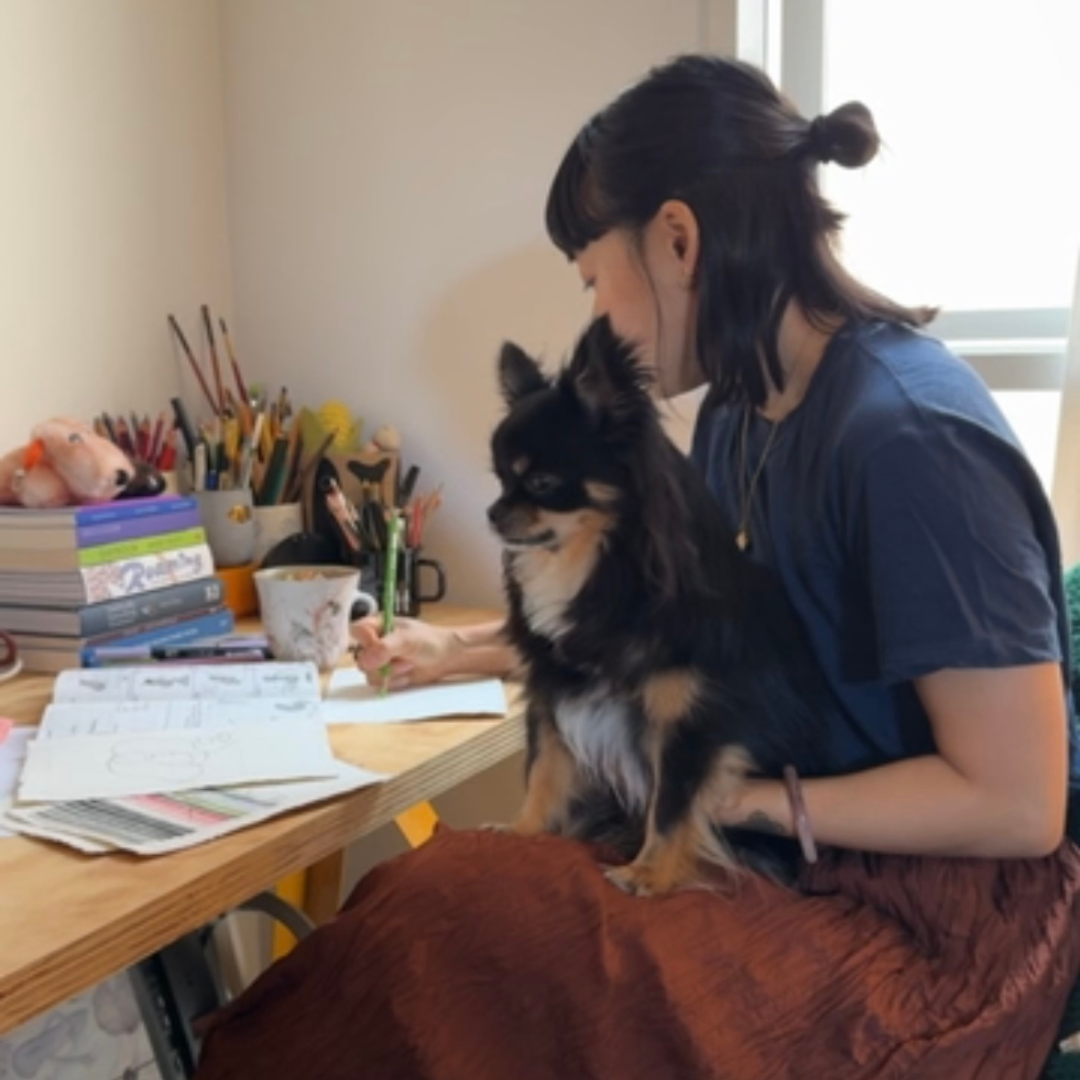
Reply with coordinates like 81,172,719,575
0,761,388,855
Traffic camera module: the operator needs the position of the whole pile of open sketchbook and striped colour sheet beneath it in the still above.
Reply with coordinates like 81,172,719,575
0,663,384,854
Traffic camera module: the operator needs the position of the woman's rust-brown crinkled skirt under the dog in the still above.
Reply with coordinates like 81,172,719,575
198,829,1080,1080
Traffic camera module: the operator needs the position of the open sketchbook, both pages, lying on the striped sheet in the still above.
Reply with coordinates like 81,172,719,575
17,664,335,802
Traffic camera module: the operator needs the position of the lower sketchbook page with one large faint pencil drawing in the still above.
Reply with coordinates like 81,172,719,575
17,720,336,802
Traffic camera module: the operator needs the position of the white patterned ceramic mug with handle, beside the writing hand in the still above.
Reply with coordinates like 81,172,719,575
255,566,379,671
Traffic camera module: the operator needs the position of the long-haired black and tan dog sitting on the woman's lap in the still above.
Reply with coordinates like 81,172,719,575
488,320,826,894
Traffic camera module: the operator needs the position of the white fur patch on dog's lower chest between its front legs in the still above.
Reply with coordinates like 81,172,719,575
554,686,651,813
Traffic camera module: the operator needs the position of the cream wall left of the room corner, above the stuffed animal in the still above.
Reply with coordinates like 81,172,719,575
0,0,230,451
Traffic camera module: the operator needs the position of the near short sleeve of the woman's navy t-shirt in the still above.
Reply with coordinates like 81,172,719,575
854,418,1062,683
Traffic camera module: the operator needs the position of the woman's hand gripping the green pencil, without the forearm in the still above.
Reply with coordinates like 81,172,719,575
352,615,465,690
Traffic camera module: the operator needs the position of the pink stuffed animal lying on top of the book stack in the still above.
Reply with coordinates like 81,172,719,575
0,418,135,509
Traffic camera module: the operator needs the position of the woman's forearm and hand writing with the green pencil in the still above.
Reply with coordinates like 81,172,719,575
352,616,518,689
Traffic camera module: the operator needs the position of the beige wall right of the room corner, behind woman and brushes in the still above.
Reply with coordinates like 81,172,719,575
220,0,708,603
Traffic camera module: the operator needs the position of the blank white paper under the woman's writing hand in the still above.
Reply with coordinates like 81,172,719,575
323,667,507,724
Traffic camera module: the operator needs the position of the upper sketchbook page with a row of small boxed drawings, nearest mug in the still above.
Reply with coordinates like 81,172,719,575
53,662,320,702
